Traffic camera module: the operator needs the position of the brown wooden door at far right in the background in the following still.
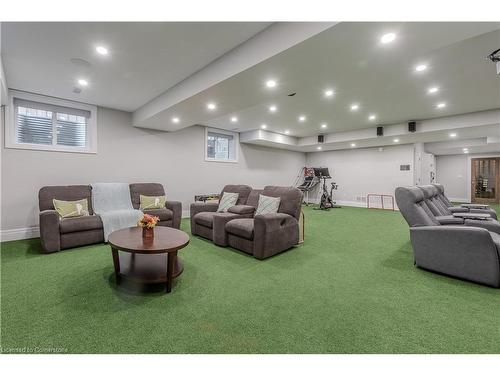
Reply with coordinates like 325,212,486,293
471,158,500,204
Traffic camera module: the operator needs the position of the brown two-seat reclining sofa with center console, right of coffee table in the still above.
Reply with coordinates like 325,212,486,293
191,185,303,259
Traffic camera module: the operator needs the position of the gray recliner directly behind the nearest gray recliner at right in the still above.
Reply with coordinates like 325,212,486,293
418,185,500,234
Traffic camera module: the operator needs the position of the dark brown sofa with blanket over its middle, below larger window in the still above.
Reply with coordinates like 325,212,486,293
38,183,182,253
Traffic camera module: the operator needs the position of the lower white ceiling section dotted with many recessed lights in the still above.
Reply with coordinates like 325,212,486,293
134,22,500,138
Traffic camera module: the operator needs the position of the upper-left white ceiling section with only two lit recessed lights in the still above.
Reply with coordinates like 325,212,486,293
1,22,270,111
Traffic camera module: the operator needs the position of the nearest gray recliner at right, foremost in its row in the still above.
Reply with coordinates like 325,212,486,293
395,187,500,288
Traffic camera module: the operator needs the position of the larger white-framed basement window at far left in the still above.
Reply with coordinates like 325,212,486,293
5,92,97,153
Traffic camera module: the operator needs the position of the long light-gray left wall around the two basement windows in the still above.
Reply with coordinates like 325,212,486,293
1,108,305,236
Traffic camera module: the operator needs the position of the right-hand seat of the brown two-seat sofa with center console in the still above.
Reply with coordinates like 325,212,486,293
224,186,303,259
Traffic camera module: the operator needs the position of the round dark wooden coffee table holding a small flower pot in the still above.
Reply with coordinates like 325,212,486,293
108,226,189,293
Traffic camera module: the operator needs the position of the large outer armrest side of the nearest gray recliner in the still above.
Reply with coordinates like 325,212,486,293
410,225,500,287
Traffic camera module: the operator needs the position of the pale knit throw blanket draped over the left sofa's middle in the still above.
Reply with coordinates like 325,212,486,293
91,183,143,242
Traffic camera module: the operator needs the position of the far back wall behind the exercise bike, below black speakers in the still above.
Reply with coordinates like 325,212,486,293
306,144,414,206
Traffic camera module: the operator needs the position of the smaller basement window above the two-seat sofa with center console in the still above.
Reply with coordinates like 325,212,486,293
205,128,238,163
